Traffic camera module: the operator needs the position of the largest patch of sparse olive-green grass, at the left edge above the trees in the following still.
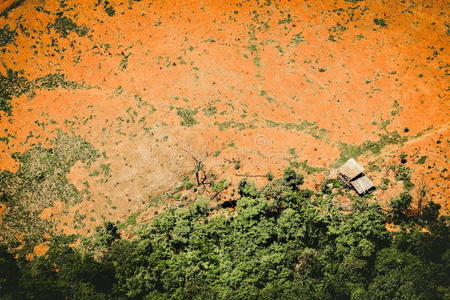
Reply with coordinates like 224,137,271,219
0,132,98,254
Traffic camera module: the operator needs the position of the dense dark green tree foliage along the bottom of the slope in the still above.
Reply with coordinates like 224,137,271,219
0,169,450,300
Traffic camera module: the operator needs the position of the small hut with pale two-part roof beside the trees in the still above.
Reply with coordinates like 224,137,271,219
338,158,375,195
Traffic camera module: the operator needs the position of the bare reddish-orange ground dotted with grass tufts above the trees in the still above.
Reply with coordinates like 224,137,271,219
0,0,450,255
